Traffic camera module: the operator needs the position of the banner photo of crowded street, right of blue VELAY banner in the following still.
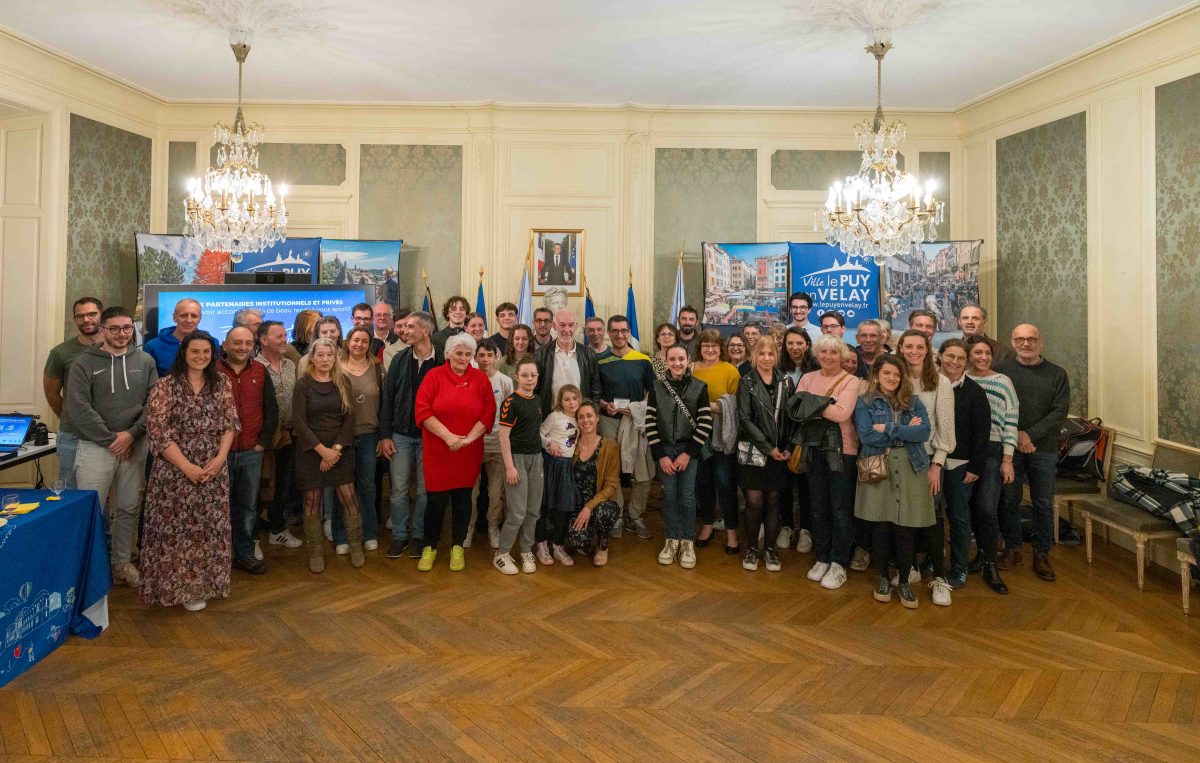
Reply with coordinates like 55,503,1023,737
883,239,983,346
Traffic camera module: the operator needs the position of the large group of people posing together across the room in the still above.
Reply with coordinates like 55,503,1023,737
44,293,1069,611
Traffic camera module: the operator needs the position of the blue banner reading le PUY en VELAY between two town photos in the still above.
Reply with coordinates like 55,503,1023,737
787,242,881,328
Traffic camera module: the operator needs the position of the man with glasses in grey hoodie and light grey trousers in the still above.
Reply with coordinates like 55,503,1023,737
64,307,158,587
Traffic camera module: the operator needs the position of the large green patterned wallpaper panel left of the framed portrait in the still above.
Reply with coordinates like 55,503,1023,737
359,145,460,309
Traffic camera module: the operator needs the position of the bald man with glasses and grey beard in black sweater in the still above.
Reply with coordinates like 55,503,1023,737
995,323,1070,581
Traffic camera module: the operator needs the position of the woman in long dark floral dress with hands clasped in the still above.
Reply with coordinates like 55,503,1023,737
138,332,240,612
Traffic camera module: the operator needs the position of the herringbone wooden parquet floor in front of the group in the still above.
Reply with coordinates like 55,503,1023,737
0,516,1200,762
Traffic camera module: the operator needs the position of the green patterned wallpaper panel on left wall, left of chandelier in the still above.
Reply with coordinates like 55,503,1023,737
66,114,151,323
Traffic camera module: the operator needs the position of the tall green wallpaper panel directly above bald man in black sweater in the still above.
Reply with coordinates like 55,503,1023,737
995,113,1087,414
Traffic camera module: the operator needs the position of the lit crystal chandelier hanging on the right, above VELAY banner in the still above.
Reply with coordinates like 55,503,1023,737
821,29,943,264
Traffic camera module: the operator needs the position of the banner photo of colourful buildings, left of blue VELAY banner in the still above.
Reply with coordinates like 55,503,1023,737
701,241,788,328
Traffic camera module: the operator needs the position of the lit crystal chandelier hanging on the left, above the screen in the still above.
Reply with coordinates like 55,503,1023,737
184,31,288,263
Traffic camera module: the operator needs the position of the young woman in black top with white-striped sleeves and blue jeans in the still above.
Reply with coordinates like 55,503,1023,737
646,344,713,570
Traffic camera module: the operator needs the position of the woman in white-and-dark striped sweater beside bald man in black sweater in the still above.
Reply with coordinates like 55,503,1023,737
967,336,1019,593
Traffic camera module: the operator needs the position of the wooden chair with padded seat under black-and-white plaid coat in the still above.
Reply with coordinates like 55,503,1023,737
1067,444,1200,590
